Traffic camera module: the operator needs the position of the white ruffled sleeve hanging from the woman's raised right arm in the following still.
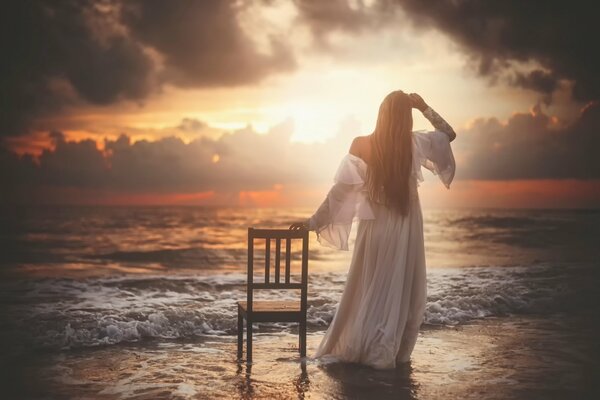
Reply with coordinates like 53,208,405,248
413,130,456,189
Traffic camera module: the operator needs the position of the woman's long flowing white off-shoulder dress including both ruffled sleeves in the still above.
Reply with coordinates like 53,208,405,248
308,109,455,369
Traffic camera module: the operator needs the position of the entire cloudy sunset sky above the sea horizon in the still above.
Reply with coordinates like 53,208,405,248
0,0,600,208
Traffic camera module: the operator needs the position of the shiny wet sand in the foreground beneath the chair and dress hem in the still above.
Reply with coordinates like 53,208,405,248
4,315,600,399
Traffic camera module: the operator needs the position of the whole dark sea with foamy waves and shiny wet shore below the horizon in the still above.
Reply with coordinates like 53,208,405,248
0,206,600,399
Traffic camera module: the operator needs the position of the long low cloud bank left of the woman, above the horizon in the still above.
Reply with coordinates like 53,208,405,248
0,120,356,201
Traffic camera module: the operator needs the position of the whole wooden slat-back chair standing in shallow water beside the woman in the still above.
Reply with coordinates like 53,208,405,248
237,228,308,363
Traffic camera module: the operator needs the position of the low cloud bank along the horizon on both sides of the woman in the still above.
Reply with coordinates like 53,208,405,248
0,103,600,202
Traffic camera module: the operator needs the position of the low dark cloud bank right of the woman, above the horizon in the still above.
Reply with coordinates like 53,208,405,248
455,102,600,180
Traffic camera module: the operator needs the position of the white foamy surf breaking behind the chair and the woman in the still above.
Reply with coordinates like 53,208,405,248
1,265,597,349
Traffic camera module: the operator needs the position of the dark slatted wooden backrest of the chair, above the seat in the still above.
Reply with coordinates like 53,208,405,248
247,228,308,312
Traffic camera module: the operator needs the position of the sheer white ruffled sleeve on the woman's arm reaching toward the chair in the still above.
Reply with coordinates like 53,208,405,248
308,153,375,250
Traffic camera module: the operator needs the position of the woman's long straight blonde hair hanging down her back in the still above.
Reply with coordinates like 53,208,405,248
367,90,413,215
